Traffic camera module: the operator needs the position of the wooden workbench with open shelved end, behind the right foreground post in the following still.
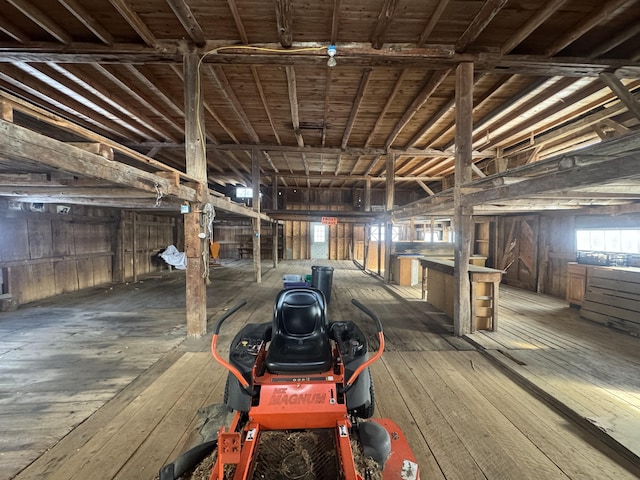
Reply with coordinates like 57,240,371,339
419,257,503,332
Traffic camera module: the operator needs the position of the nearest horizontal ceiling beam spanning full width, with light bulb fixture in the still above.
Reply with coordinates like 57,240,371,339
0,42,640,77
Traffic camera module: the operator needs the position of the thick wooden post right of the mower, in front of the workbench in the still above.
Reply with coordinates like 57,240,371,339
453,63,473,337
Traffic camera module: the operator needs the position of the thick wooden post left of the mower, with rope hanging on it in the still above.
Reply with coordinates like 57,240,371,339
183,53,207,337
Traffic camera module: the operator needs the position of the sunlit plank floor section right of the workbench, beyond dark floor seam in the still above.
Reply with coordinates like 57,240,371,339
470,286,640,461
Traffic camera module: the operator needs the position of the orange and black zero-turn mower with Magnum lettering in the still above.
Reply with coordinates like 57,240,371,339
160,288,420,480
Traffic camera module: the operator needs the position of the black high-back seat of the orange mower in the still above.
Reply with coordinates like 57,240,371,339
266,288,333,374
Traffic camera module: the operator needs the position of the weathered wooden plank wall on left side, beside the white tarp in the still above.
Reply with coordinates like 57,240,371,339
0,202,176,304
